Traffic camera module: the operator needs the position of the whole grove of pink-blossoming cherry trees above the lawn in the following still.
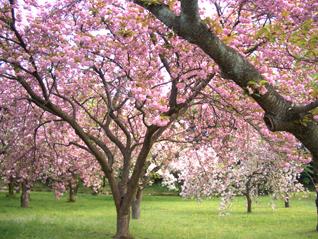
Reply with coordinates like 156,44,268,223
0,0,318,238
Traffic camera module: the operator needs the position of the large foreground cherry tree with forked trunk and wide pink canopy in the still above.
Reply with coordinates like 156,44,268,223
0,0,318,235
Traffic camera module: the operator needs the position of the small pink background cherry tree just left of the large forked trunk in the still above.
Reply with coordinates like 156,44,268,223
38,120,103,202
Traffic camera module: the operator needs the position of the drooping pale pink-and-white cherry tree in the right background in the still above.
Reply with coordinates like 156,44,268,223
162,102,310,211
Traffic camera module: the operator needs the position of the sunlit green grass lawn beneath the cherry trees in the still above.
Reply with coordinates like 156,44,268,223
0,192,318,239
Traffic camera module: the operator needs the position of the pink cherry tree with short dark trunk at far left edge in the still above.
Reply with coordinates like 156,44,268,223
0,88,48,207
